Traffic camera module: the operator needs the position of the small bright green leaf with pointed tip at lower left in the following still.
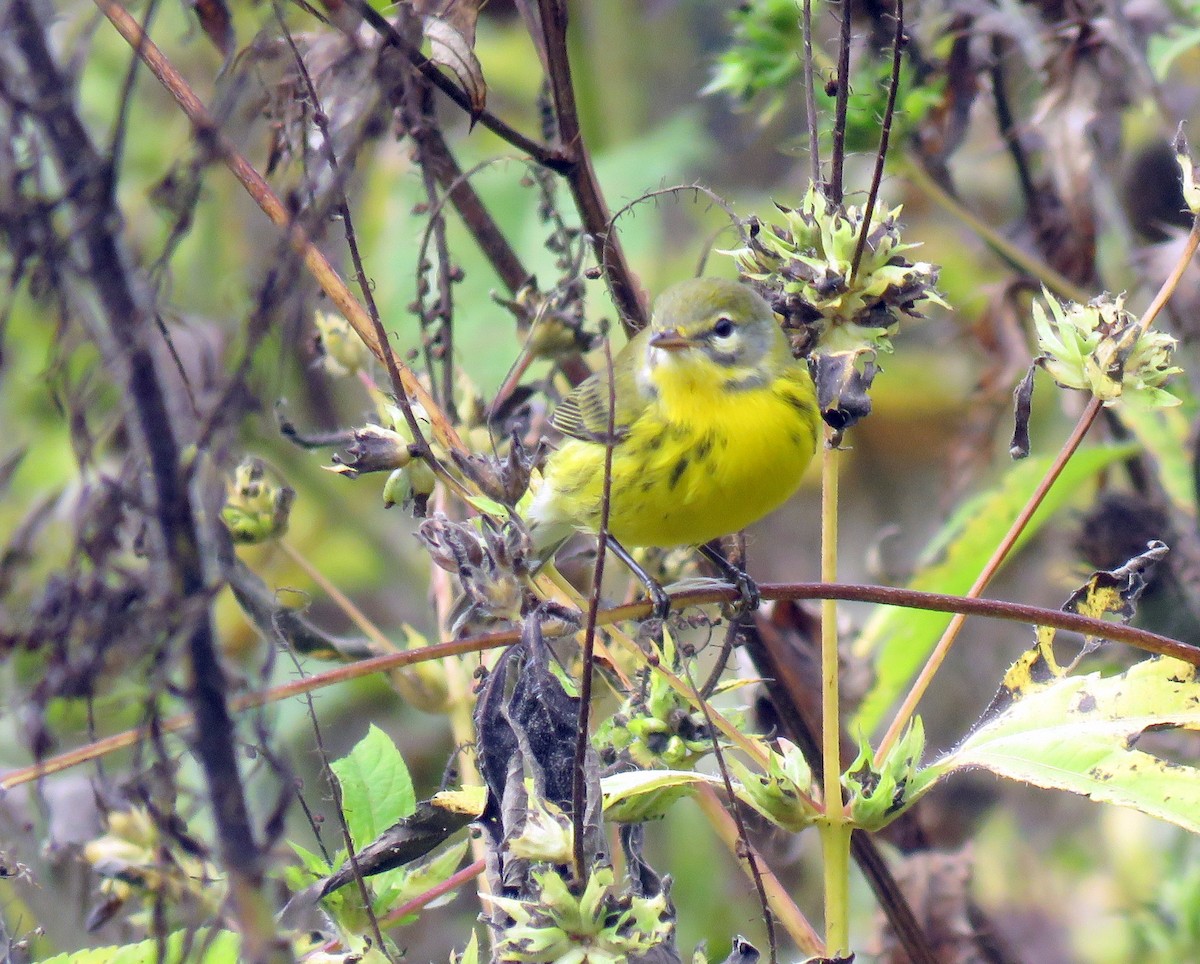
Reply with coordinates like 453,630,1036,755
330,724,416,849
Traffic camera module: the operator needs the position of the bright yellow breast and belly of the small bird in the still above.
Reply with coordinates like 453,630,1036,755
544,359,817,546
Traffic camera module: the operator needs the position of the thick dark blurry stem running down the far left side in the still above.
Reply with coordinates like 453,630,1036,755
0,0,274,960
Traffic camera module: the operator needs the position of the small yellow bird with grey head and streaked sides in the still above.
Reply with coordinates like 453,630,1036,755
527,279,821,601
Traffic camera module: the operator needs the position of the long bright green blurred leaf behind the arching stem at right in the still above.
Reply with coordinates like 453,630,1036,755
850,445,1136,734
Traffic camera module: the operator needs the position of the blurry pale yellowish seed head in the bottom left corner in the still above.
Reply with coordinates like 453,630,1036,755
83,808,223,927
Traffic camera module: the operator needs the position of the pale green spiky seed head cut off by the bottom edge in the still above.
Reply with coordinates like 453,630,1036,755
486,867,674,964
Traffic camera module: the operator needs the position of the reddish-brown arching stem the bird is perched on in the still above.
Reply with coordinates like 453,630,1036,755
7,582,1200,790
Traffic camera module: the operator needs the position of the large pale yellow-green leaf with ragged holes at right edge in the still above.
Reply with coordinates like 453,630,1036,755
925,647,1200,833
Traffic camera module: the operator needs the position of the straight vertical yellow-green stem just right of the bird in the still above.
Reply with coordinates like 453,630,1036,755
817,434,851,956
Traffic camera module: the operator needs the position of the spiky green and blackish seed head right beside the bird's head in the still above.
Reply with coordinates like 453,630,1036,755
722,185,946,353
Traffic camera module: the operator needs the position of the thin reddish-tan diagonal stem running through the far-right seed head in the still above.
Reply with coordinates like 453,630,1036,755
876,220,1200,759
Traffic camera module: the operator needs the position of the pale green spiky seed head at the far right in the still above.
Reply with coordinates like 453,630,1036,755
1033,289,1182,406
